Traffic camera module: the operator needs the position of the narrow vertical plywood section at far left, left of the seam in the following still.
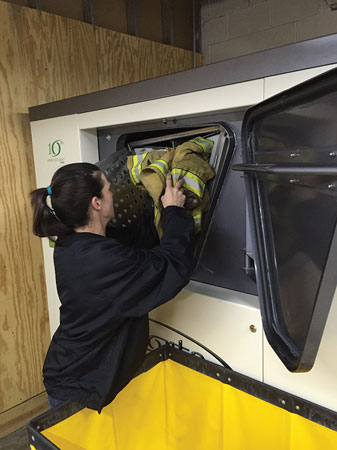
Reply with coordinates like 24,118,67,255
0,2,49,411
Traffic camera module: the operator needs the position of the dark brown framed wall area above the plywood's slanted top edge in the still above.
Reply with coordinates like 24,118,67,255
5,0,194,50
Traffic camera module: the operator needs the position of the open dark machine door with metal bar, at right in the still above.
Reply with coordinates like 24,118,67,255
234,70,337,372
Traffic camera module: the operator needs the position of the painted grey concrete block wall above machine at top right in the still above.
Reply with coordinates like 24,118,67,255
201,0,337,64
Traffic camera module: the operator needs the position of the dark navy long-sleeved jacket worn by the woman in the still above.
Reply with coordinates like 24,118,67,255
43,206,194,411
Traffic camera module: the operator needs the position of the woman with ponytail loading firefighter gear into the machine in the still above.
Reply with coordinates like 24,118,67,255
31,163,194,411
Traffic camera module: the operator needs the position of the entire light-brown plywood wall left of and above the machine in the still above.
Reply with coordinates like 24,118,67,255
0,0,201,413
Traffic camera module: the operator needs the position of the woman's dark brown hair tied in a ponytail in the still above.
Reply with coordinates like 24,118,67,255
30,163,104,239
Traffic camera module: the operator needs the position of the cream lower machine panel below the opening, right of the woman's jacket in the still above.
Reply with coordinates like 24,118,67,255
150,289,263,381
